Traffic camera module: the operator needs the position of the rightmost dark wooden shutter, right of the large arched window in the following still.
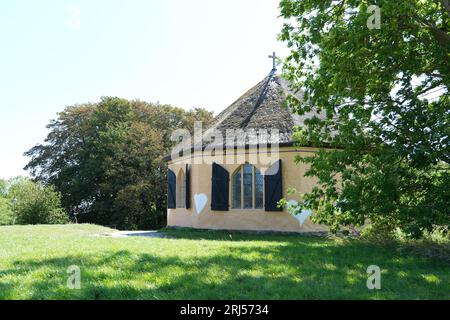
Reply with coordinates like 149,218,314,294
264,160,283,211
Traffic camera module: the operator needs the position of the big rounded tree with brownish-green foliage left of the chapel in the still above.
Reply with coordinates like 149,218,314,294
26,97,212,229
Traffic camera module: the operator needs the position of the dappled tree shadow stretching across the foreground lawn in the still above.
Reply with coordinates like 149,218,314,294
0,231,450,299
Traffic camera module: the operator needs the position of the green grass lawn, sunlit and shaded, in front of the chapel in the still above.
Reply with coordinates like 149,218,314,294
0,225,450,299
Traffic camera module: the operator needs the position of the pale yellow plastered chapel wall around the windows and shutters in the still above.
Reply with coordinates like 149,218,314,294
167,147,326,232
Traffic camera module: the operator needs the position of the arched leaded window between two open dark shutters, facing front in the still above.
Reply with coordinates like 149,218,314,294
231,163,264,209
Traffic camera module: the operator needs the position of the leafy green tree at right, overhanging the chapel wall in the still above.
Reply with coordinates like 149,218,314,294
280,0,450,237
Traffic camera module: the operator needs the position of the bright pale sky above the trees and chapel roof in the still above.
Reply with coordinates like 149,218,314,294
0,0,287,178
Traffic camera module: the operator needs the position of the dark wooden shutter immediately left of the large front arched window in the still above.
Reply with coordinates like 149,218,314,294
211,163,230,211
